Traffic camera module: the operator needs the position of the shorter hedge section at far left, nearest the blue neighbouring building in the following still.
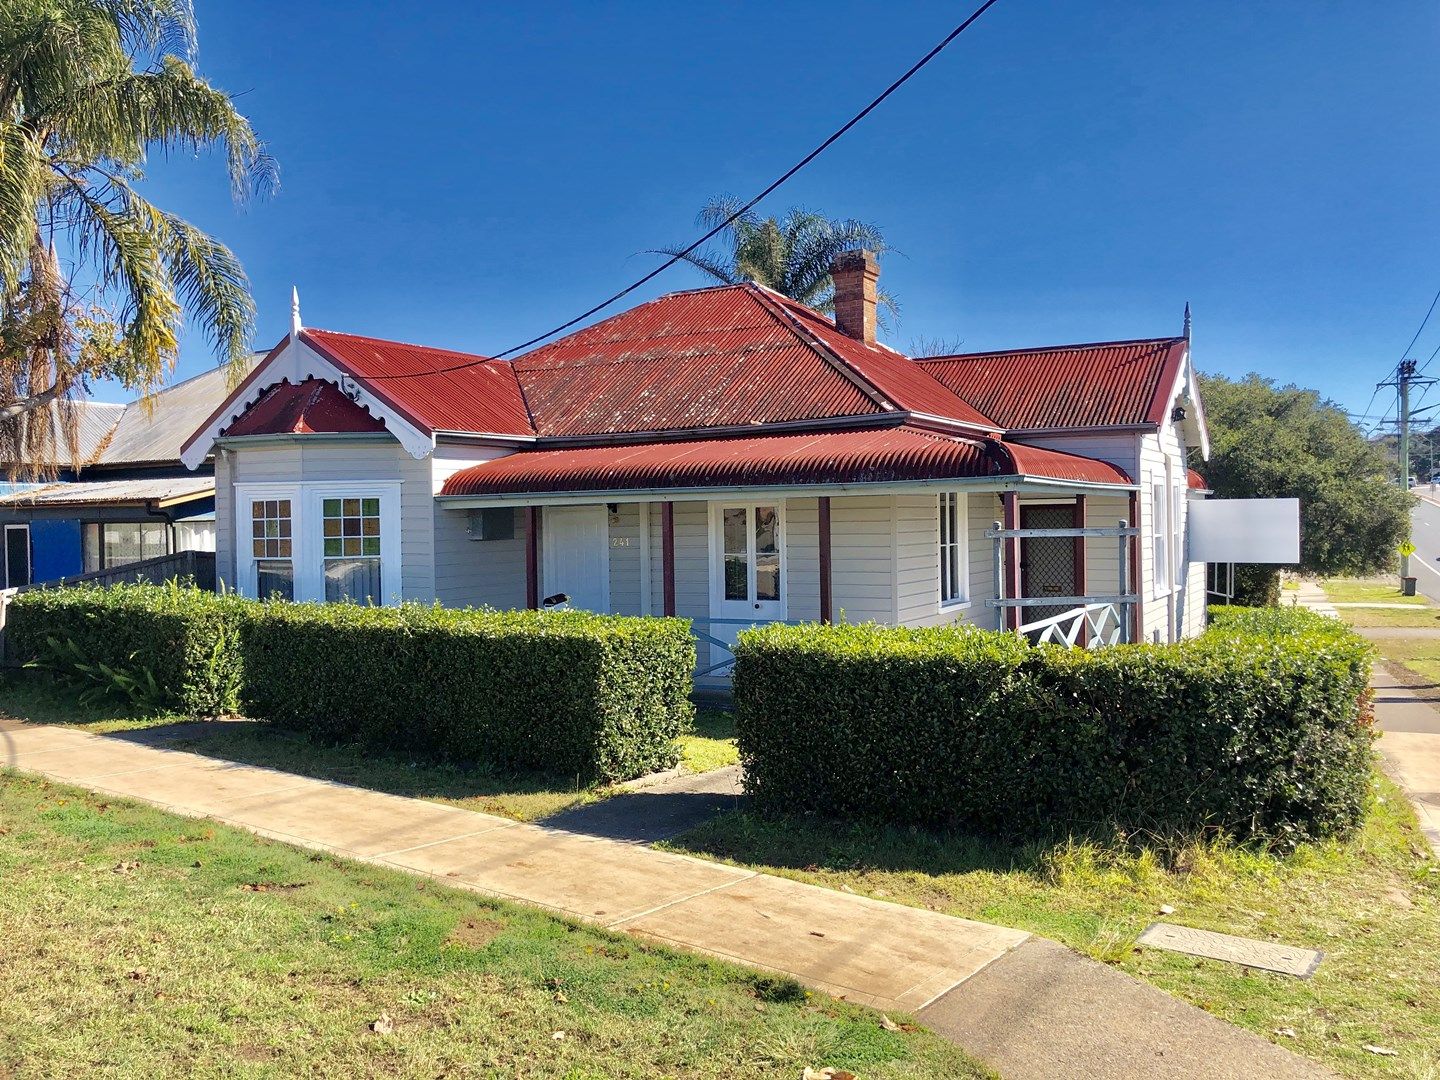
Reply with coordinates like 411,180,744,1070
6,583,242,716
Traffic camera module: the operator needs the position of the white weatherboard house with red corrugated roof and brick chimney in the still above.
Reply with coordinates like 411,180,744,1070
183,252,1207,672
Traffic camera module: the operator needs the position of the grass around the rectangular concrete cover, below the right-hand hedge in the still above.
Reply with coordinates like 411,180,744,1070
670,773,1440,1077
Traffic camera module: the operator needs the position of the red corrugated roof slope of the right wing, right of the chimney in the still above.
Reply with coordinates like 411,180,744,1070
916,337,1187,431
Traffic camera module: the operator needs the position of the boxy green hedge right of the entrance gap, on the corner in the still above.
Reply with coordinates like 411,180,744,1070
734,608,1372,841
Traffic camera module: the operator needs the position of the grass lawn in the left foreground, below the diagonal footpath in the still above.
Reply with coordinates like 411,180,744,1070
0,769,986,1080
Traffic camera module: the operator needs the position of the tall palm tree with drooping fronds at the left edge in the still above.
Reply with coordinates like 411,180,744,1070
0,0,275,471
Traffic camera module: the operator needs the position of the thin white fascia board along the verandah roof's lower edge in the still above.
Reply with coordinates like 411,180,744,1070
435,477,1138,510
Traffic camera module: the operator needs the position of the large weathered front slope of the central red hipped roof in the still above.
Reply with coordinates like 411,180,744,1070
514,285,886,435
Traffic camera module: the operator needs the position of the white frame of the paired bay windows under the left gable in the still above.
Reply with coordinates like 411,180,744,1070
235,480,403,606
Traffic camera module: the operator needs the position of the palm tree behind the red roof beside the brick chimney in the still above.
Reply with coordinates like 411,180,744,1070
647,194,900,324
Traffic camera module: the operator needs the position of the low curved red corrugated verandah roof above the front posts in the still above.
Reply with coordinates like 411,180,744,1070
441,426,1129,497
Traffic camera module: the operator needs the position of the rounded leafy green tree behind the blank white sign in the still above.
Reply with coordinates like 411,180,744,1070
1195,374,1416,575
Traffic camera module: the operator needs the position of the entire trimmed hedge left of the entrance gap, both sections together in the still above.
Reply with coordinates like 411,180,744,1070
9,585,696,780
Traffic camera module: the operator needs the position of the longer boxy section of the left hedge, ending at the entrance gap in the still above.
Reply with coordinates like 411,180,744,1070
240,603,696,780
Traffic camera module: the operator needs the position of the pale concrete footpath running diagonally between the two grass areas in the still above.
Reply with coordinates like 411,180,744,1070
0,719,1331,1080
